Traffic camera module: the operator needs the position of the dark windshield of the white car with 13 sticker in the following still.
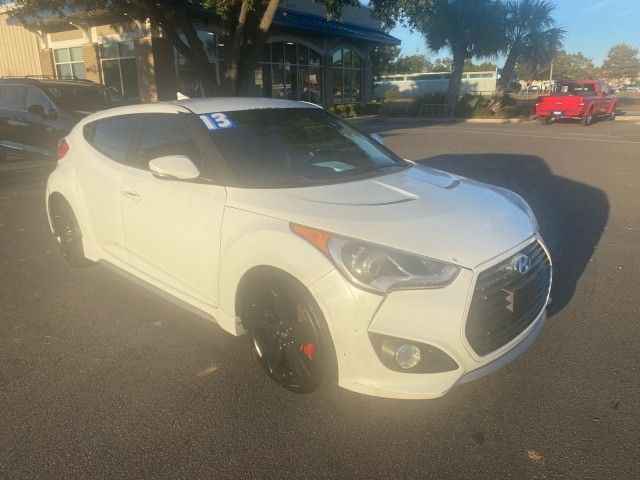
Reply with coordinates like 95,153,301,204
200,108,408,188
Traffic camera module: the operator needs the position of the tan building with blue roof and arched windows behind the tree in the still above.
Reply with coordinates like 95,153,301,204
0,0,400,106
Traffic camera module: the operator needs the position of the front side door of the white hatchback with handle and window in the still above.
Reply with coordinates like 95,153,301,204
121,114,226,305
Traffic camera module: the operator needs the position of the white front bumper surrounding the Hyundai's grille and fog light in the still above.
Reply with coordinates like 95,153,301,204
309,237,548,399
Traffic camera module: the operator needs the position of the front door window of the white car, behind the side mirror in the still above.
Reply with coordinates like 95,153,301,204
135,114,200,169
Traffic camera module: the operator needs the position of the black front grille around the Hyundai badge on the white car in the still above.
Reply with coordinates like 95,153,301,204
465,241,551,356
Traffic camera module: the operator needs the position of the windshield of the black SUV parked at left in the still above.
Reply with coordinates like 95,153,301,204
47,85,129,112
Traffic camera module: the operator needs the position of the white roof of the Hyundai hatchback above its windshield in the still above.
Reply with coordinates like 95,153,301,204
167,97,322,114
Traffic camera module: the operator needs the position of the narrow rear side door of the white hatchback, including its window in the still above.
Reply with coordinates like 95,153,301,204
76,115,140,263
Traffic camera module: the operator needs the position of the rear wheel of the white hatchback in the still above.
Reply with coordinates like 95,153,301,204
49,197,93,267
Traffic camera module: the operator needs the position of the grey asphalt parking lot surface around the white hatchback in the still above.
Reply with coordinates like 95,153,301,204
0,118,640,479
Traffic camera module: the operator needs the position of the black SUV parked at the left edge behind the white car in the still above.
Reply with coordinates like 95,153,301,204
0,77,130,156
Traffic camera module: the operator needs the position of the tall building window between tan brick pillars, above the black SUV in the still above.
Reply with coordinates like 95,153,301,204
100,40,140,98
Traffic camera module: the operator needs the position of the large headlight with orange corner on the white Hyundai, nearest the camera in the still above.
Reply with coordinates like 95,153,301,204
291,224,460,293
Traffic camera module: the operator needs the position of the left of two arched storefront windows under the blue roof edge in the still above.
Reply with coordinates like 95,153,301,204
256,42,322,104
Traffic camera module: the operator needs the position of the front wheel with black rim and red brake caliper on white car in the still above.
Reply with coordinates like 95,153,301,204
241,272,337,393
